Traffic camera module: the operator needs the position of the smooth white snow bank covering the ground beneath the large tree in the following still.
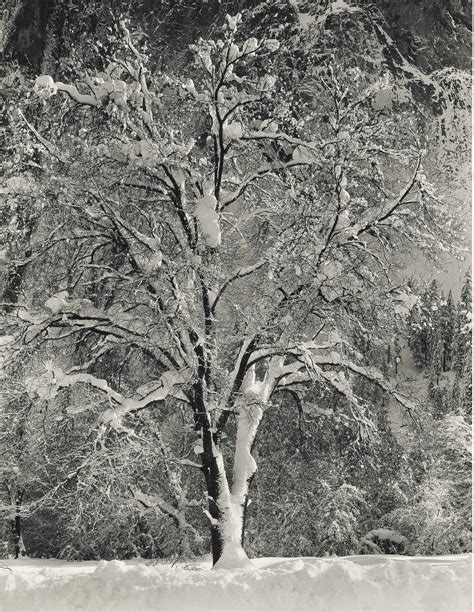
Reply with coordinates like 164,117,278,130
0,555,471,612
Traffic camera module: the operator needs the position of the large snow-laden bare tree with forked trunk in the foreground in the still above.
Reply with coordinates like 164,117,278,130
0,8,460,567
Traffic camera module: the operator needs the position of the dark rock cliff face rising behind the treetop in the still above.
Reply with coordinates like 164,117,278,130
5,0,472,72
